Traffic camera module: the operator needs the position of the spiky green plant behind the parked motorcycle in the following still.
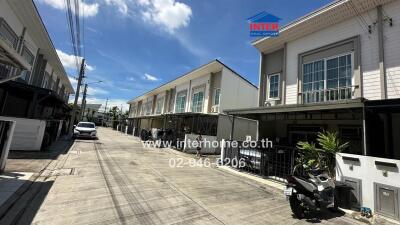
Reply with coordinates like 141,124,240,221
295,131,349,177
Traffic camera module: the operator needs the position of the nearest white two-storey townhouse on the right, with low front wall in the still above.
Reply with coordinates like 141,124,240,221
225,0,400,220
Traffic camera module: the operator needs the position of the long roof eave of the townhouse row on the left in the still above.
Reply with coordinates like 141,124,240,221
7,0,74,94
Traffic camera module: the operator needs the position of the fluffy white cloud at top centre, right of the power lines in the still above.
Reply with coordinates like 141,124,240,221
137,0,192,33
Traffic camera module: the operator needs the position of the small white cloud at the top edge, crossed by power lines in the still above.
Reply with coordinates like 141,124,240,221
38,0,99,17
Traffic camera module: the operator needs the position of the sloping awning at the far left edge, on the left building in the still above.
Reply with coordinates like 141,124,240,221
0,38,31,70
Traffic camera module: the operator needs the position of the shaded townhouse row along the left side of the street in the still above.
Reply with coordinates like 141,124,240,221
0,0,74,150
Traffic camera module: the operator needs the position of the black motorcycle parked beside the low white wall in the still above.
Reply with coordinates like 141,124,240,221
284,170,338,219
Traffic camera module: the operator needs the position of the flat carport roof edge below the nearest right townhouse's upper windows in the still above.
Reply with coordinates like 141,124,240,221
224,98,364,115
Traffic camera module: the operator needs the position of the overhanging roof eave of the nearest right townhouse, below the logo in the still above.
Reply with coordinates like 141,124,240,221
252,0,393,52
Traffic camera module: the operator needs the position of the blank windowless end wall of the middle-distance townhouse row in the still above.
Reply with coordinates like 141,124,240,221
219,68,258,113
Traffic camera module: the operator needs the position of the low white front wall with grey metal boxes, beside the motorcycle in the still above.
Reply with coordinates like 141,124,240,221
336,153,400,213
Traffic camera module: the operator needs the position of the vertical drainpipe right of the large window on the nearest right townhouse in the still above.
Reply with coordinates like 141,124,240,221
376,5,387,99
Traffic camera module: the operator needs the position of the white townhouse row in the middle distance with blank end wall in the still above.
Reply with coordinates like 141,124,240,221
128,60,257,152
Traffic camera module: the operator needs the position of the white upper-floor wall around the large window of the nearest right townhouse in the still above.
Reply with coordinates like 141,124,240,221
286,1,400,104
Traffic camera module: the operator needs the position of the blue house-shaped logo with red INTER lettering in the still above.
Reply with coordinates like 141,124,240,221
247,11,281,37
